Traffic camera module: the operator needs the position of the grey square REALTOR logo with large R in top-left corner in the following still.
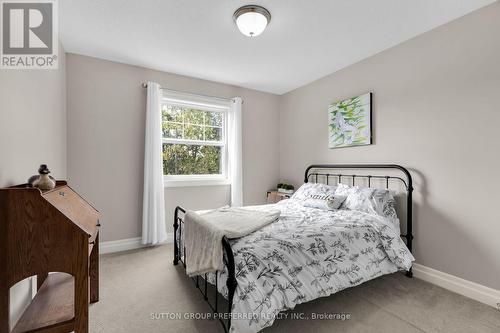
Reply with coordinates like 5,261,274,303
0,0,59,69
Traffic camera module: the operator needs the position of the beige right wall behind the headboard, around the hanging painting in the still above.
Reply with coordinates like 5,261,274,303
280,2,500,289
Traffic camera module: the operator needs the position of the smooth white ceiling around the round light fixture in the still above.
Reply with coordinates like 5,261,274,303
59,0,495,94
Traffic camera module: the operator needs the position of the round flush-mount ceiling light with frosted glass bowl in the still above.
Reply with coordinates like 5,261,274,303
233,5,271,37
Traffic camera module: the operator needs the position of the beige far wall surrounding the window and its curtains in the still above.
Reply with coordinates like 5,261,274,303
67,54,279,241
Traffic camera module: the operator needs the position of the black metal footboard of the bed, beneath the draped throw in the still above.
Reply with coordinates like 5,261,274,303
174,206,238,332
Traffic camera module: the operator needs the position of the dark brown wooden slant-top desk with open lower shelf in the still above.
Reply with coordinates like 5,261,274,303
0,181,100,333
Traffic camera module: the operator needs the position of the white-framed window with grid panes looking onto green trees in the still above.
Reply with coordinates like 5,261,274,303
161,95,229,186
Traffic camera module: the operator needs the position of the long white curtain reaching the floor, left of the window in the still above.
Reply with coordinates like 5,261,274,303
142,82,167,245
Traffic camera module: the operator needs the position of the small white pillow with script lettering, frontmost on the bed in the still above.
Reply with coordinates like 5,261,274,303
291,183,346,210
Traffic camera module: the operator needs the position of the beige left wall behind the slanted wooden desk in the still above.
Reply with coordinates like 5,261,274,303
0,45,66,325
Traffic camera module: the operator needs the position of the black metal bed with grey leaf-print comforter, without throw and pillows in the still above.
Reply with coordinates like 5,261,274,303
174,164,414,333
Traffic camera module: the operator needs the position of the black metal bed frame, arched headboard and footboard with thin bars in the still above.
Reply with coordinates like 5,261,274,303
174,164,413,333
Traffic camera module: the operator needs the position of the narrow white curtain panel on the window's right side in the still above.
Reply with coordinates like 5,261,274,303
228,97,243,207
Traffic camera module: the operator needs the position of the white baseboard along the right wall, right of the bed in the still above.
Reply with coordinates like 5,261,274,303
413,263,500,310
